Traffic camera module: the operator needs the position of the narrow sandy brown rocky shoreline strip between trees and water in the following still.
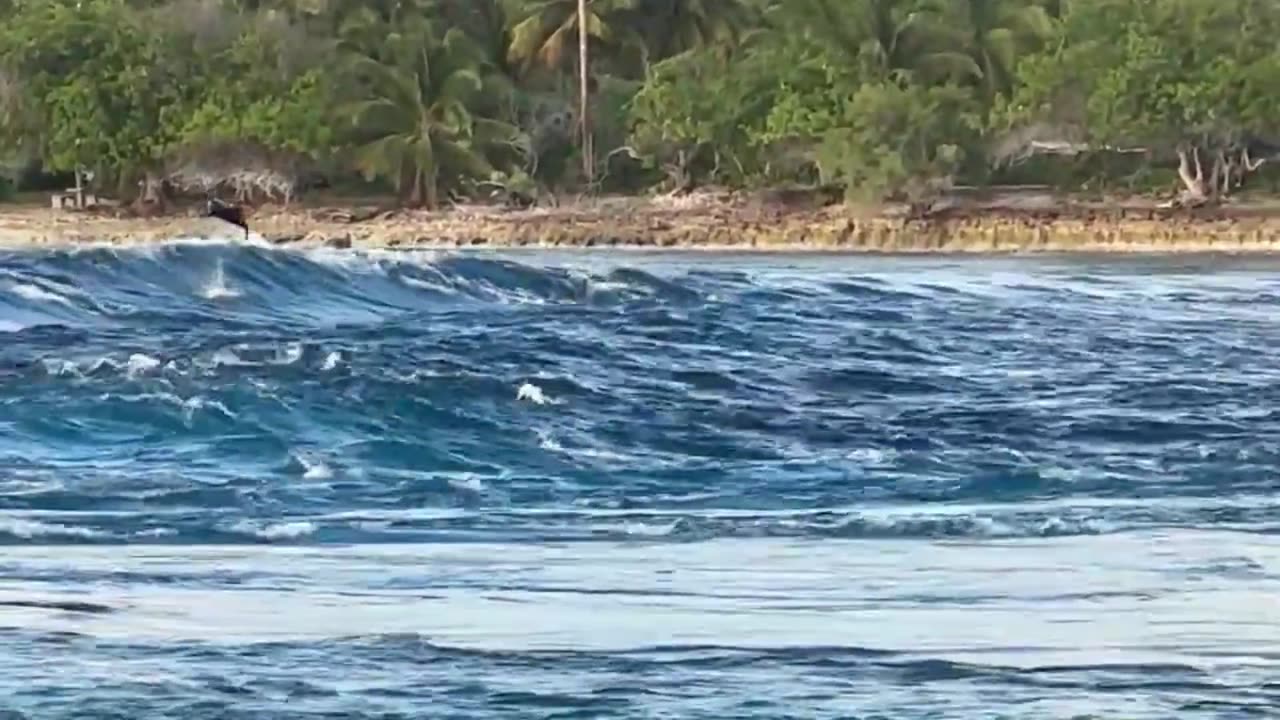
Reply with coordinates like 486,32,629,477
0,193,1280,255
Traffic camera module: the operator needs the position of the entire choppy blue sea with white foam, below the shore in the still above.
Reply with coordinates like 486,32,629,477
0,242,1280,719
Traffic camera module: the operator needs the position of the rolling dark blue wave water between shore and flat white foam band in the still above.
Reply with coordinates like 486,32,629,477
0,243,1280,544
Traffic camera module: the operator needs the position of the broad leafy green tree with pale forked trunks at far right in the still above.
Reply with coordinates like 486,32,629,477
1005,0,1280,195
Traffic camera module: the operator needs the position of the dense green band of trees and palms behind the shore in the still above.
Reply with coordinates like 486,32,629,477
0,0,1280,206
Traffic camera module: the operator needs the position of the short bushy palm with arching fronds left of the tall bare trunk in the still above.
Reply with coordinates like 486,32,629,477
344,19,525,208
